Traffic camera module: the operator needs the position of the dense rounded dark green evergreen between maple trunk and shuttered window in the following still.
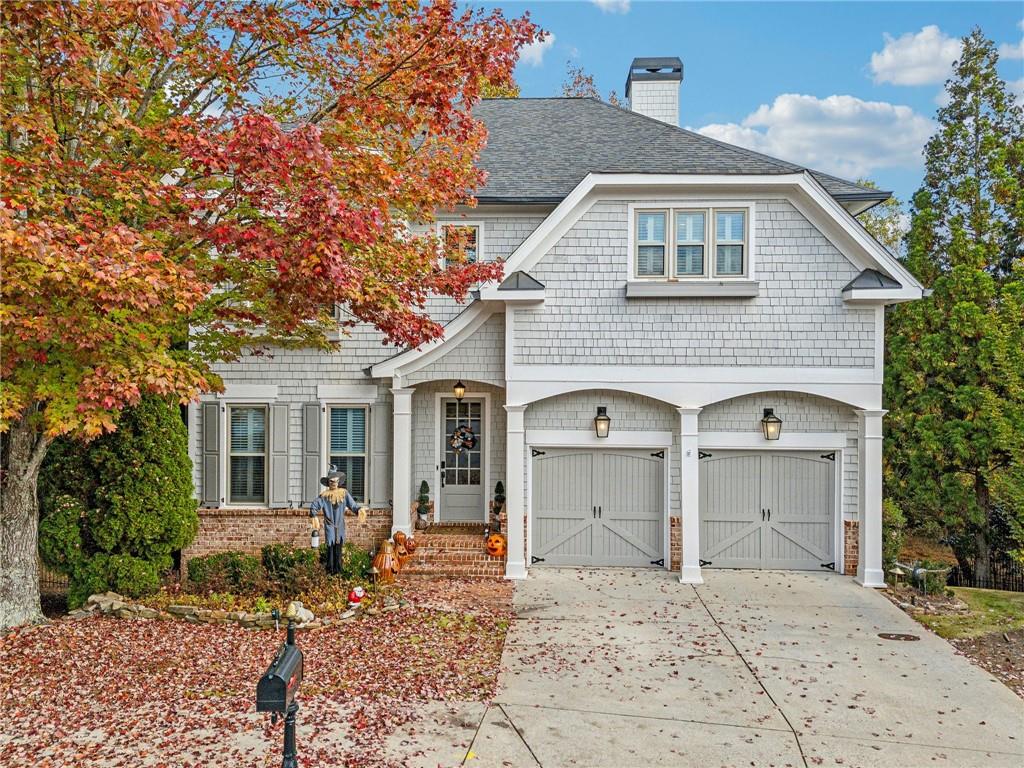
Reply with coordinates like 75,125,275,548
39,396,199,607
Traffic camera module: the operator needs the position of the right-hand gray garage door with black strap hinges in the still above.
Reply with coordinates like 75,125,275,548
700,451,836,570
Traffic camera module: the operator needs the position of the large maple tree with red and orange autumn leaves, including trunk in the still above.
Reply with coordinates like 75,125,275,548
0,0,538,627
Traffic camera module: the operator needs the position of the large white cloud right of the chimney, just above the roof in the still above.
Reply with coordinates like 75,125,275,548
697,93,934,178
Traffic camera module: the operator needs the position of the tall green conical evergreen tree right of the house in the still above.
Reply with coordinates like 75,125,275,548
885,29,1024,578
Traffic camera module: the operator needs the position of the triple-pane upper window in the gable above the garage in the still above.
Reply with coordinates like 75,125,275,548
633,207,750,280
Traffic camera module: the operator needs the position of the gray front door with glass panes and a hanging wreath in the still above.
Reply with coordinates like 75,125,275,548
439,397,485,522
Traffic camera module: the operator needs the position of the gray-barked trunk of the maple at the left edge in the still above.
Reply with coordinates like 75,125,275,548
0,417,50,631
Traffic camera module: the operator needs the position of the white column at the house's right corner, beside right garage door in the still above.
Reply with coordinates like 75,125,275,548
854,411,889,587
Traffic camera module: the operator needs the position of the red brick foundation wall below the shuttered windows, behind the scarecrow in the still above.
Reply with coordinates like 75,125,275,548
181,509,391,570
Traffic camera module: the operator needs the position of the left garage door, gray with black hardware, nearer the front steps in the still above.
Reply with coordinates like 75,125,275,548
530,449,665,565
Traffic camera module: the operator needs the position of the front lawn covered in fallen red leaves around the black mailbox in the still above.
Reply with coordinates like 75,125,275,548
0,581,511,768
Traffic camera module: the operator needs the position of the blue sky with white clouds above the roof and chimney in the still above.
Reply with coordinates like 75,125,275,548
471,0,1024,201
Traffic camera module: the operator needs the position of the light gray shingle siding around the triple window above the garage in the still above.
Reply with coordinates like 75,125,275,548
514,199,874,368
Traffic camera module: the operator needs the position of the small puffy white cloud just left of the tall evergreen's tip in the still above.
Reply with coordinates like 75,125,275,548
871,25,961,85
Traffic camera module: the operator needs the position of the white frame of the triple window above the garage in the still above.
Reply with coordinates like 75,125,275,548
626,198,757,285
